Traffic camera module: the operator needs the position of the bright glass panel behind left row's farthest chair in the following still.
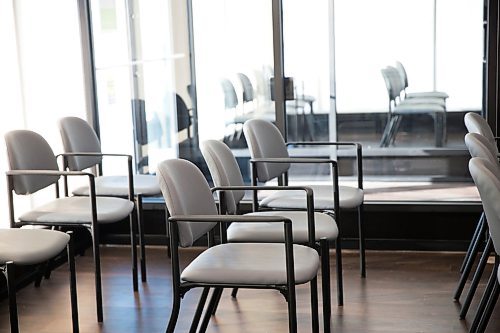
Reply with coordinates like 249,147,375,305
92,0,177,174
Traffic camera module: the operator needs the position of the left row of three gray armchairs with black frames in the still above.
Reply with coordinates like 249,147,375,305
0,117,161,332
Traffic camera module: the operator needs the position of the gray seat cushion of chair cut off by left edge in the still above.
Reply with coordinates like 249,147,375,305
0,229,70,265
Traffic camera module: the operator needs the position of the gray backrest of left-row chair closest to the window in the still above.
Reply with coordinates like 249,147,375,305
59,117,102,171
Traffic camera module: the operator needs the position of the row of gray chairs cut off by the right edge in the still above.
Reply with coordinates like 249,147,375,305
454,112,500,333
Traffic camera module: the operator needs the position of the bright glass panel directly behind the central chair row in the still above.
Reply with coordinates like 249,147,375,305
193,0,275,182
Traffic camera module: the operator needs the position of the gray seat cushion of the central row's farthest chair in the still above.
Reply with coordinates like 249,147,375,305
260,185,364,210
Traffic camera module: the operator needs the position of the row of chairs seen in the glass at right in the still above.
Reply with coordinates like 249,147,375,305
380,62,448,147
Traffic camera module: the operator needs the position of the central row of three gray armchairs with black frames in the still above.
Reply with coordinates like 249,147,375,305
162,119,366,332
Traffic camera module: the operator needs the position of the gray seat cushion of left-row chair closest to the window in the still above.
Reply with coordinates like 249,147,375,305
73,175,161,197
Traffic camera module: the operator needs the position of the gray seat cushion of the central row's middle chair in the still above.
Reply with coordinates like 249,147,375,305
227,210,339,243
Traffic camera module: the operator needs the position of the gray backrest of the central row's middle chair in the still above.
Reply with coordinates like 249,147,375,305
200,140,245,214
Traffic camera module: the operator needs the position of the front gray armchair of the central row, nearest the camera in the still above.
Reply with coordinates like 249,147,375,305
158,159,320,333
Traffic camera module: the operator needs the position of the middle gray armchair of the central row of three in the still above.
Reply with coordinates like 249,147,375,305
201,140,343,332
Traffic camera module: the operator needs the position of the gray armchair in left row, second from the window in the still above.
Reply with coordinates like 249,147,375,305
5,130,137,322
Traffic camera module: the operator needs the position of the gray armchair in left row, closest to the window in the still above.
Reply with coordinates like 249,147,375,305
59,117,161,284
